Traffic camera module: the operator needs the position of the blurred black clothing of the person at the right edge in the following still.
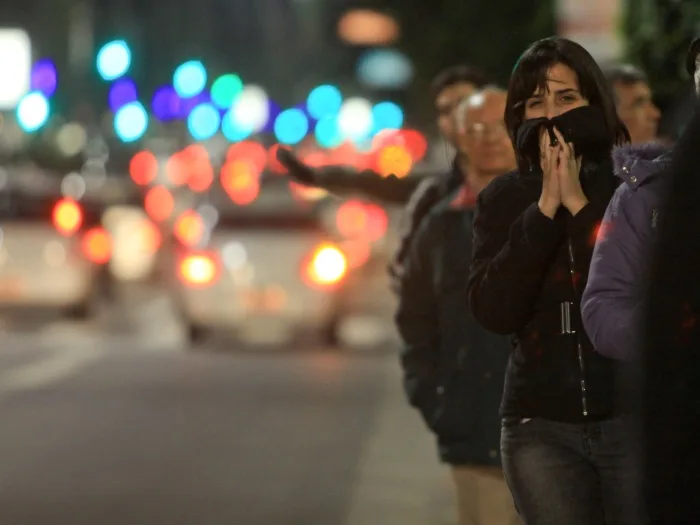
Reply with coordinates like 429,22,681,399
642,103,700,525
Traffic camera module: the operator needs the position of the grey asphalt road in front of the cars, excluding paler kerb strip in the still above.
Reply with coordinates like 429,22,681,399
0,338,392,525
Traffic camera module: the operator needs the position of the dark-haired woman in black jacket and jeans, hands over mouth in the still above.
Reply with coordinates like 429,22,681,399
469,37,644,525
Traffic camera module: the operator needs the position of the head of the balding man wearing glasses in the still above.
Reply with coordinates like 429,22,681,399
455,86,516,175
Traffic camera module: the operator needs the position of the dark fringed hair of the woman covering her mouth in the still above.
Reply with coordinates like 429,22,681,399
504,37,630,170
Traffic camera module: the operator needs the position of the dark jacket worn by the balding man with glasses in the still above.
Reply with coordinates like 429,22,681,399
396,186,511,466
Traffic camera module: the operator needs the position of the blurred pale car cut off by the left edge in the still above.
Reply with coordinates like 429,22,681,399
0,184,111,318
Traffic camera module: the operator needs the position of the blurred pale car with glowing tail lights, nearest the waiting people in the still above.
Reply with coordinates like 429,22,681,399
164,178,348,344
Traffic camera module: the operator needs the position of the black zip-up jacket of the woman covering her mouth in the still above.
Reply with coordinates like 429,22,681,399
468,160,617,422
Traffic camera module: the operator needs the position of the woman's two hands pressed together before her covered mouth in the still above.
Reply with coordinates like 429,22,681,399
538,127,588,219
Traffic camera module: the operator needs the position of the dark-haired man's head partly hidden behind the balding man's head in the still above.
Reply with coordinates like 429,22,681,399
431,66,487,146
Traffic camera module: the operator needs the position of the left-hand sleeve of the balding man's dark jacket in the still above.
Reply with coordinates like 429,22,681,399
395,220,439,422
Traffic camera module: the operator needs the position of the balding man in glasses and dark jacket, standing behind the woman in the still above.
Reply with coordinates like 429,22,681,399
396,88,518,525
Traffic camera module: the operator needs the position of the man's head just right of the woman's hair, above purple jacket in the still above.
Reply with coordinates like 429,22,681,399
606,64,661,144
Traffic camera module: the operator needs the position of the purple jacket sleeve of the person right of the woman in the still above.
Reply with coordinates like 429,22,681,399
581,184,651,360
